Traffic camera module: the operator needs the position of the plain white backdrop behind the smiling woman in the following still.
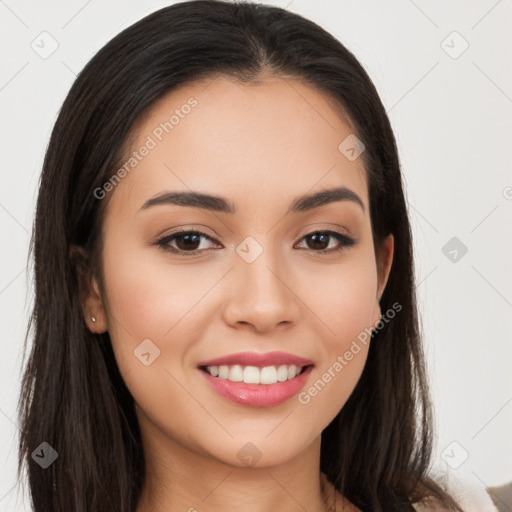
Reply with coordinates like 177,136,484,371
0,0,512,512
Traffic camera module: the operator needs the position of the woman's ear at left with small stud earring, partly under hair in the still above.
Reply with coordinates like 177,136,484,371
69,245,108,334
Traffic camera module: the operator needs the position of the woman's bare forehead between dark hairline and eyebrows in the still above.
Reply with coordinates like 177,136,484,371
105,73,368,216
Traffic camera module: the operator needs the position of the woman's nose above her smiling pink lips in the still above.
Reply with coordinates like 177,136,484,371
223,245,301,333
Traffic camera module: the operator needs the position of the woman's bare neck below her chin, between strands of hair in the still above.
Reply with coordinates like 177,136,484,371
136,408,326,512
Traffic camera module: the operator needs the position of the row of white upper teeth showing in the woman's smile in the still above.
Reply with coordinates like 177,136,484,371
206,364,303,384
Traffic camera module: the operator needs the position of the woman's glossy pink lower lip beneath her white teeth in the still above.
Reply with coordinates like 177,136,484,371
199,366,313,407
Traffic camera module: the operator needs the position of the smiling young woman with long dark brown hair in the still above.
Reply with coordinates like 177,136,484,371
19,1,472,512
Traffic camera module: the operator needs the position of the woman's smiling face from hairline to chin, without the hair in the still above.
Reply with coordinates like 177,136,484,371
87,77,393,466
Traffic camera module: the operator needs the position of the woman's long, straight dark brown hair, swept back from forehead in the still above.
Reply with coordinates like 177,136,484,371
18,0,460,512
